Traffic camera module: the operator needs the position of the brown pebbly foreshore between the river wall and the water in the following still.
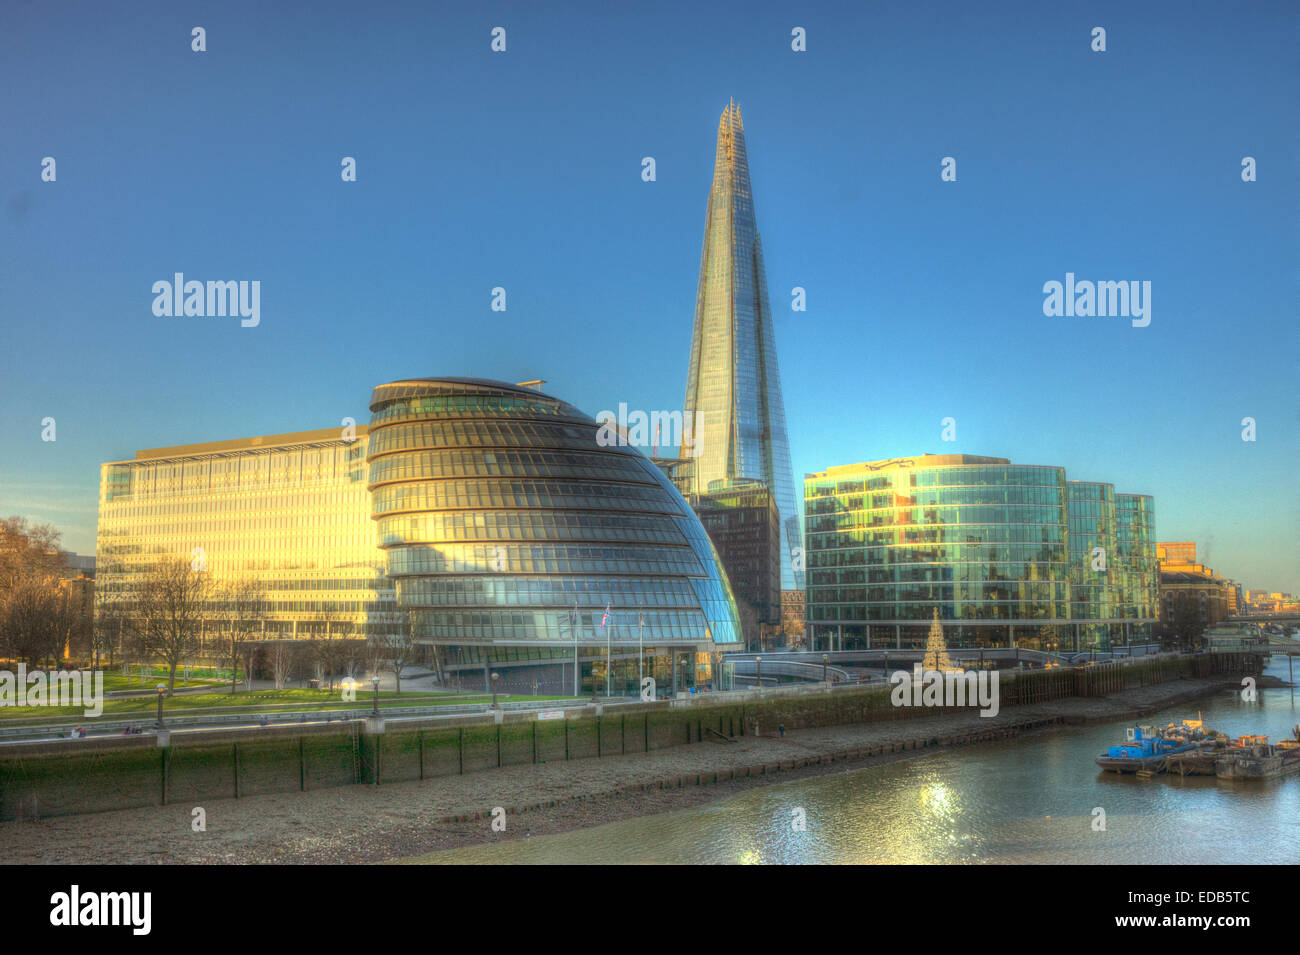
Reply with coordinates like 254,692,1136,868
0,681,1225,864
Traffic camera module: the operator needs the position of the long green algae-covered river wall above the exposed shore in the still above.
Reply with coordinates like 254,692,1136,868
0,654,1262,820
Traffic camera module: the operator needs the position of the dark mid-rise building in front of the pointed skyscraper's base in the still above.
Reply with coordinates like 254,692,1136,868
692,481,774,650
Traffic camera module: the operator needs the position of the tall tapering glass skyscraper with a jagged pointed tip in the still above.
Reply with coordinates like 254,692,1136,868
681,101,803,590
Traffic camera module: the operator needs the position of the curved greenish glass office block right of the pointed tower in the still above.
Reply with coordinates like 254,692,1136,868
805,455,1156,650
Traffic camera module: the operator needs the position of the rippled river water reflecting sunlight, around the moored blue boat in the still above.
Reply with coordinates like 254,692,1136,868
412,659,1300,864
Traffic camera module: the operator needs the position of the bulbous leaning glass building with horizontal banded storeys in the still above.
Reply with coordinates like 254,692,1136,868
367,378,740,694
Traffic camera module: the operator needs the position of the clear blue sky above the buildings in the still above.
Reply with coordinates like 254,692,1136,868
0,0,1300,591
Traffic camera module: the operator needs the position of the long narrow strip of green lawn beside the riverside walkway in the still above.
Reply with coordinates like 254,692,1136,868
0,681,567,725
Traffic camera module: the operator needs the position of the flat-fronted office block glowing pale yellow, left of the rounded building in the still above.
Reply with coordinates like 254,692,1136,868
96,427,397,638
